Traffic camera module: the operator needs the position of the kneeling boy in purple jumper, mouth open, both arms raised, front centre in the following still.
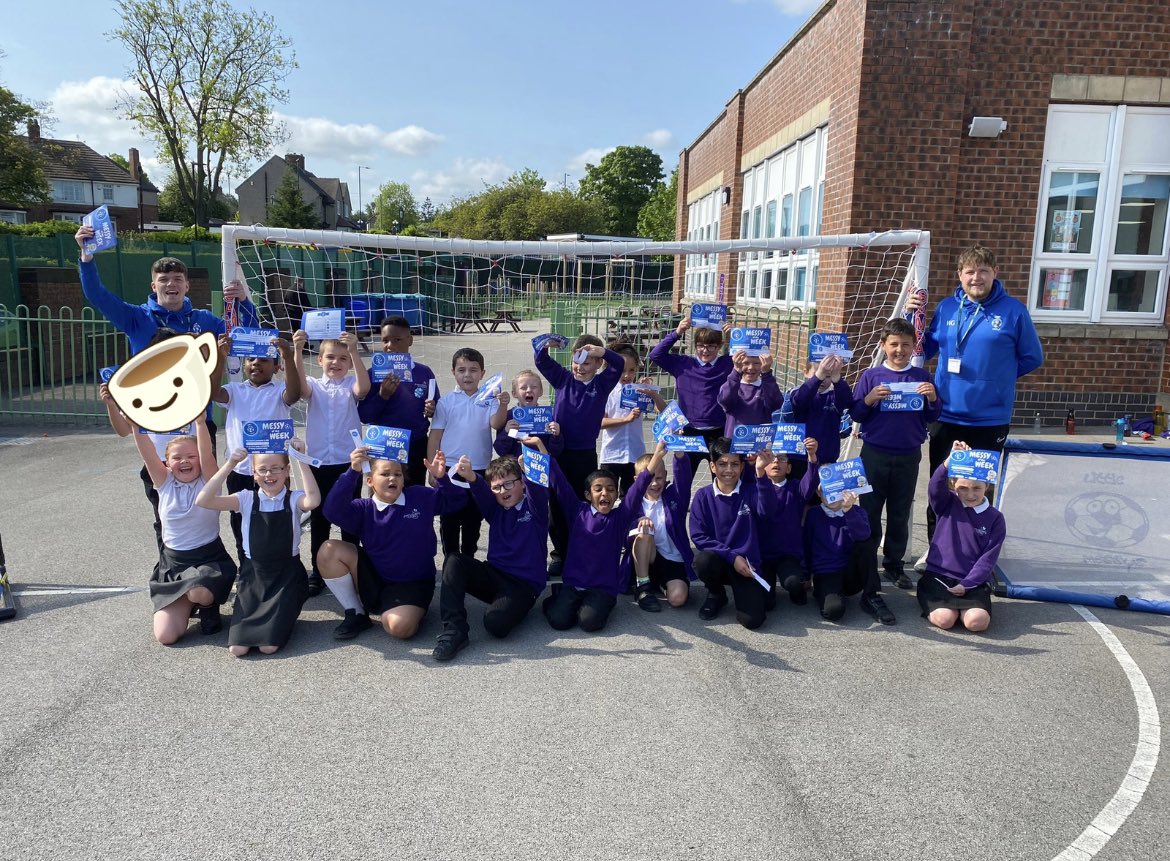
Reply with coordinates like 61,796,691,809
537,445,652,632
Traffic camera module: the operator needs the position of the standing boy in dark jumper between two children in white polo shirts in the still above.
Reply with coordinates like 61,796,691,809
358,317,439,484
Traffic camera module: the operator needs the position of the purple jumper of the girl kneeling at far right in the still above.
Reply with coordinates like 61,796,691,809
927,463,1007,590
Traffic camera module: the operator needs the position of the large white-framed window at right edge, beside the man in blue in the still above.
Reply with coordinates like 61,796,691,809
1028,105,1170,325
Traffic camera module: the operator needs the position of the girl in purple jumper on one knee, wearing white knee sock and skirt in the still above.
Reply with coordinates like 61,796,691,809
317,446,463,640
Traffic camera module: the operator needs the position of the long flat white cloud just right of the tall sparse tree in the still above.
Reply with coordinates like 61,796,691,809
275,113,443,160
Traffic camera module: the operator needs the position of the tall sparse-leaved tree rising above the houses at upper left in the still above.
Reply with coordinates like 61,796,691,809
109,0,297,225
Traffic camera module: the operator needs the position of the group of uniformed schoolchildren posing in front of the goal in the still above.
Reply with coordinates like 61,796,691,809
103,306,1004,661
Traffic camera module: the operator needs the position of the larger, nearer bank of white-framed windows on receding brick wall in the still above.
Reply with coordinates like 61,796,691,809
737,126,828,305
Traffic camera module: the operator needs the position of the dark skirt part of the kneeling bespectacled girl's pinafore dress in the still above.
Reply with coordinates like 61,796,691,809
227,556,309,646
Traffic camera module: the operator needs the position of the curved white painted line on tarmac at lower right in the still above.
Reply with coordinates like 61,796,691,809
1053,604,1162,861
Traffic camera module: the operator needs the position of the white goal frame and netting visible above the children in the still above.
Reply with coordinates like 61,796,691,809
222,225,929,404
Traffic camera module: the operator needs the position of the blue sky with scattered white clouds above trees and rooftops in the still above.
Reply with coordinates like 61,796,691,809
0,0,821,207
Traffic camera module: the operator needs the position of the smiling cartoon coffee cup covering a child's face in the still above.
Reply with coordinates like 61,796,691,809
109,332,216,434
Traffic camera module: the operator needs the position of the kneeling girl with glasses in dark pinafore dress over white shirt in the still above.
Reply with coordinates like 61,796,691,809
199,440,321,657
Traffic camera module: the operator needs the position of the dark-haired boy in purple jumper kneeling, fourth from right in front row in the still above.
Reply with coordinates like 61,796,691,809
690,436,776,628
